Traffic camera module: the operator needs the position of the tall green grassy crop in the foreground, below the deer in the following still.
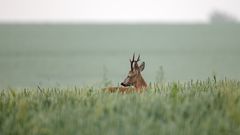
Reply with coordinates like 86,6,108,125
0,79,240,135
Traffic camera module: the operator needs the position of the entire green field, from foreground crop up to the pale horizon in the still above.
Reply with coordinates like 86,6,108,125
0,24,240,135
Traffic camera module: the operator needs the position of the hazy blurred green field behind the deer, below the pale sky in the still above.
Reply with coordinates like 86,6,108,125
0,24,240,89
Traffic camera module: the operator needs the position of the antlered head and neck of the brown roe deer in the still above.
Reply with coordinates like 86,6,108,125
121,54,147,89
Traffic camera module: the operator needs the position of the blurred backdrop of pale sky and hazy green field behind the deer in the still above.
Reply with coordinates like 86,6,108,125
0,0,240,88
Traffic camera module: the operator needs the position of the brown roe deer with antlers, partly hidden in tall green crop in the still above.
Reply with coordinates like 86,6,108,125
104,54,147,93
